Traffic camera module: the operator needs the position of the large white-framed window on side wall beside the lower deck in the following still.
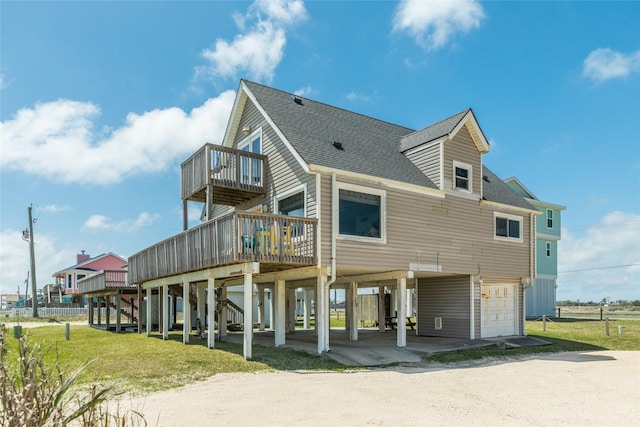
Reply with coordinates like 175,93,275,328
338,185,386,241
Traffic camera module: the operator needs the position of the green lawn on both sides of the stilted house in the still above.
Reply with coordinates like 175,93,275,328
3,319,640,393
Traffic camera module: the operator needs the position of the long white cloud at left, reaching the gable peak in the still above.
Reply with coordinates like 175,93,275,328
0,91,235,185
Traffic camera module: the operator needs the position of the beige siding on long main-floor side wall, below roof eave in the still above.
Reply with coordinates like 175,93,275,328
322,175,530,277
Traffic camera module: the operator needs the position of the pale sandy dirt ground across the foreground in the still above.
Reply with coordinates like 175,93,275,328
121,351,640,426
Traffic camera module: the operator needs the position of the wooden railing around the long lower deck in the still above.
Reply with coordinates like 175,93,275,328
128,212,317,283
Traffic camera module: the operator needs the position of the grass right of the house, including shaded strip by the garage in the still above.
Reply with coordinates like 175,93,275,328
425,319,640,363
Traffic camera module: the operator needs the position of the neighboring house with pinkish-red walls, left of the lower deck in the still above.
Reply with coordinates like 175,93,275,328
53,251,127,295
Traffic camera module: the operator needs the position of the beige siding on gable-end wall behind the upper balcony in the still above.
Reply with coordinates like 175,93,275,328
234,101,316,218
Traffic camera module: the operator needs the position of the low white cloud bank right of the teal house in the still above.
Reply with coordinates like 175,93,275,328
557,211,640,301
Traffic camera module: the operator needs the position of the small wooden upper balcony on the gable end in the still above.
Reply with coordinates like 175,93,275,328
182,144,268,206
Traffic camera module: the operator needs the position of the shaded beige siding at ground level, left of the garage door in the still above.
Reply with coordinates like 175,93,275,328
417,276,471,338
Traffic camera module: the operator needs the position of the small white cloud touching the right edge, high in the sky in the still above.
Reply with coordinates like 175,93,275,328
582,48,640,82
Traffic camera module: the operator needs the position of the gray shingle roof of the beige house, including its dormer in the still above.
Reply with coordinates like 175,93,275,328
243,80,535,210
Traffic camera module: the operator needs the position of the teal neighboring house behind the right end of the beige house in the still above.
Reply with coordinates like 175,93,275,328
504,177,566,317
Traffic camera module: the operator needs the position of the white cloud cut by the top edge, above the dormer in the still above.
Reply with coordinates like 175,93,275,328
393,0,484,50
